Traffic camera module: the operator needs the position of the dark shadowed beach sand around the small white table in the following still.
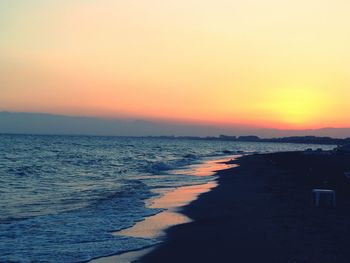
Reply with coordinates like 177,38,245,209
141,153,350,263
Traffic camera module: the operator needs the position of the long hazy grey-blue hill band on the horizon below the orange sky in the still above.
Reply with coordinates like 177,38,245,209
0,111,350,138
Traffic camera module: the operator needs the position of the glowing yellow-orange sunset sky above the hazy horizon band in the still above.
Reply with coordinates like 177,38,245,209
0,0,350,129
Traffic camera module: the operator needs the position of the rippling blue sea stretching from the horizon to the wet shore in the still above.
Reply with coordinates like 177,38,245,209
0,135,333,262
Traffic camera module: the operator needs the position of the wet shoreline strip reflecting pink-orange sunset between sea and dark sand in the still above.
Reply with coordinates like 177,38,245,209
88,157,235,263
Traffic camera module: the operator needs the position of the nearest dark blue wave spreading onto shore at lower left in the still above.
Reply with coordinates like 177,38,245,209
0,180,162,262
